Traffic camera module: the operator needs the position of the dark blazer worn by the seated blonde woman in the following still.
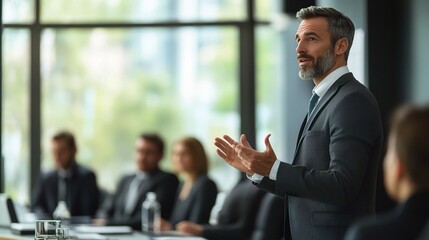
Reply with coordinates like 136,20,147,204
169,175,217,226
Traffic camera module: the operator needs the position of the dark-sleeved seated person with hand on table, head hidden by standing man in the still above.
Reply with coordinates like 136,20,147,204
176,174,266,240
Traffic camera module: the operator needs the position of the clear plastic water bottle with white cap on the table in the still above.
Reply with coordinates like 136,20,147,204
142,192,161,233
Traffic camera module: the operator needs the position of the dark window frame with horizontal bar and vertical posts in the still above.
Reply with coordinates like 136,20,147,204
0,0,269,199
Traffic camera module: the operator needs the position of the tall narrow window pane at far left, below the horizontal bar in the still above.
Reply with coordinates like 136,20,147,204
1,29,30,202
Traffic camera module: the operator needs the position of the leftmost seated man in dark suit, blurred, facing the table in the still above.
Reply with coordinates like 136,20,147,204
31,131,99,218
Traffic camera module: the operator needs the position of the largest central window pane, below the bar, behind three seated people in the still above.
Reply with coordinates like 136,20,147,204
41,27,239,190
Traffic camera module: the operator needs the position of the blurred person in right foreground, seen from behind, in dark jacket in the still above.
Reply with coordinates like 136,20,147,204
346,106,429,240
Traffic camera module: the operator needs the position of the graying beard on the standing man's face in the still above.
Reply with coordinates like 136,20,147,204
299,48,335,80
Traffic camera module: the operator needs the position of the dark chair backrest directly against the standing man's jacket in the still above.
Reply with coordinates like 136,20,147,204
251,193,284,240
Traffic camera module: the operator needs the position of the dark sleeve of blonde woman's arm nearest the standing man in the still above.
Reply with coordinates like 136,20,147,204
189,180,217,224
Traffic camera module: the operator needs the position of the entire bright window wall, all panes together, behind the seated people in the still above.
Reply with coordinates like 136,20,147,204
1,0,278,204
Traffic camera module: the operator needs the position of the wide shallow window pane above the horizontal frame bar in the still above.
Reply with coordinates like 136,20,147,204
41,0,246,23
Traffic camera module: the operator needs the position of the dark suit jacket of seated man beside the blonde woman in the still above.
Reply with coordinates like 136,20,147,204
97,169,179,229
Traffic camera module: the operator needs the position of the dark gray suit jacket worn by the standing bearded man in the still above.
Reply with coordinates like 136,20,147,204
258,73,383,240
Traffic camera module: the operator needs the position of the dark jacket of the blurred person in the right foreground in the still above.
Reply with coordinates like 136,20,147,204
345,193,429,240
